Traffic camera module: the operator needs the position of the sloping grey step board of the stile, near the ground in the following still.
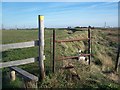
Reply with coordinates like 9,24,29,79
10,67,38,82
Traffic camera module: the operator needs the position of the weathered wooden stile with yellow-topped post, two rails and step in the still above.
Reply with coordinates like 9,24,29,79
0,15,45,88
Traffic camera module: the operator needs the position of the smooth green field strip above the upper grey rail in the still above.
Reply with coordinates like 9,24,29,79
2,30,38,44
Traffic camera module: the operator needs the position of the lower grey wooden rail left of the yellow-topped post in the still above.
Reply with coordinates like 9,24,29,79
0,58,35,68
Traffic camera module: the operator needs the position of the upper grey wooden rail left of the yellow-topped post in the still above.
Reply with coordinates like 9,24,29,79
2,41,38,51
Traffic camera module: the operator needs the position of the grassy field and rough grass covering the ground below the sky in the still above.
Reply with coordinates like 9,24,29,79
2,29,120,89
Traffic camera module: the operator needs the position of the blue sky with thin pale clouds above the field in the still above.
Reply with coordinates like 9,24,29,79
2,2,118,28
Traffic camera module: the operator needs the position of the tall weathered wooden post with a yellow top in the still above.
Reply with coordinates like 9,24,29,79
38,15,45,81
